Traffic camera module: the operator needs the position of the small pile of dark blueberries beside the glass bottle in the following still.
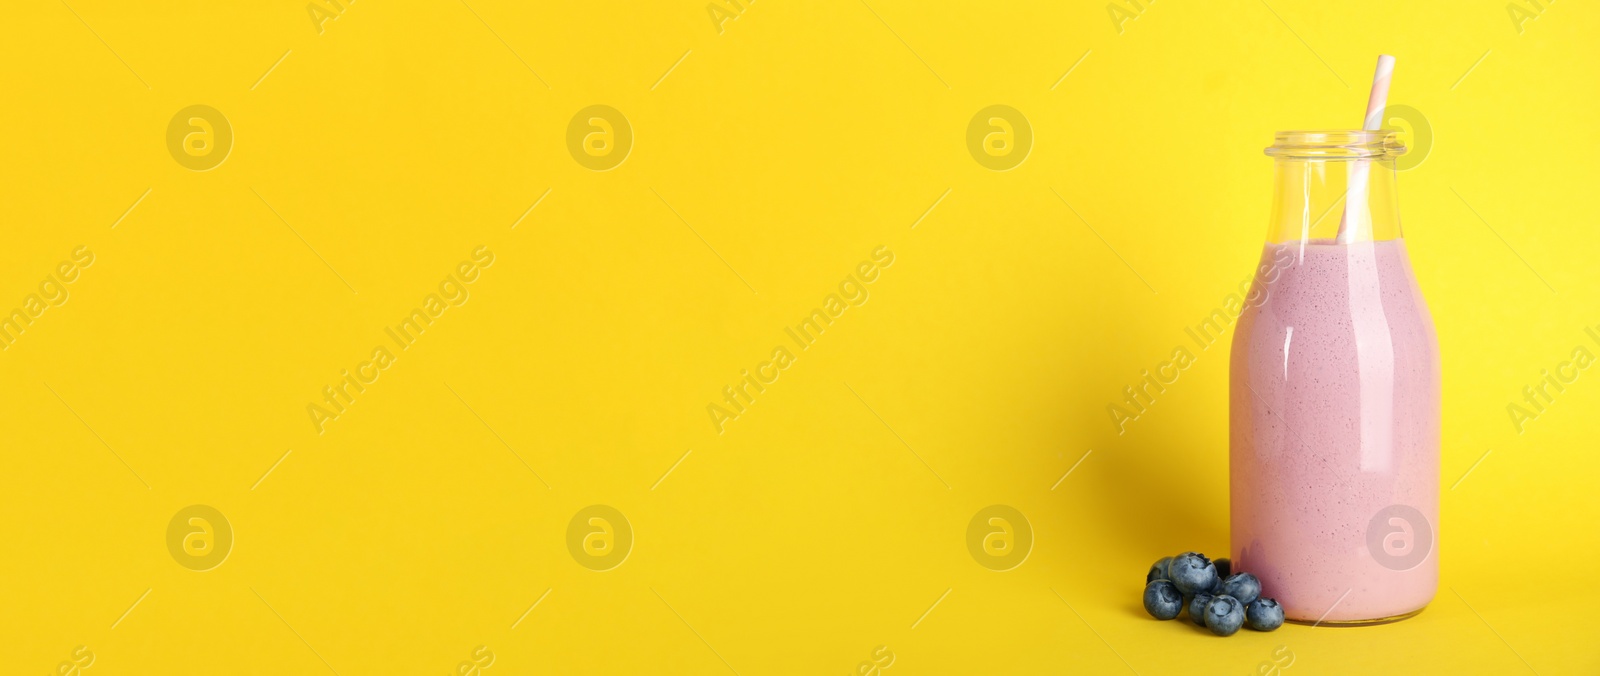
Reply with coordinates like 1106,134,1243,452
1144,551,1283,636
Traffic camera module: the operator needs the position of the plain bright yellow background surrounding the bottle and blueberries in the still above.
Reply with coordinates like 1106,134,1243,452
0,0,1600,676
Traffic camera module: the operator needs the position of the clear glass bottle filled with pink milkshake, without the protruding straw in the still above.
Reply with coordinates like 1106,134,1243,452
1229,131,1440,625
